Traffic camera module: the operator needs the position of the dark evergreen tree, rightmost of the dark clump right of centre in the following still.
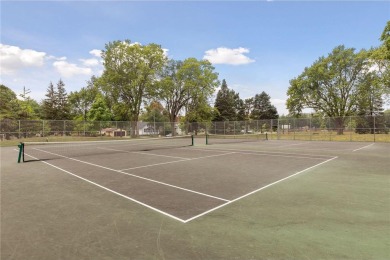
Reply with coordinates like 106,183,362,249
251,91,279,120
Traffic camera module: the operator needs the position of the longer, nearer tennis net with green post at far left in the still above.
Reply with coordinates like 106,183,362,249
18,136,193,162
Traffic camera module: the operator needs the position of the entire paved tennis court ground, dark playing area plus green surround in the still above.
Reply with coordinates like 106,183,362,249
1,137,390,259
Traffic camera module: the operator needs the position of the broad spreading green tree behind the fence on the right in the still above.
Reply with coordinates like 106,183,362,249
287,45,369,134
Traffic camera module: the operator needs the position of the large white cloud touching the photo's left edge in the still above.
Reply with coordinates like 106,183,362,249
0,44,46,74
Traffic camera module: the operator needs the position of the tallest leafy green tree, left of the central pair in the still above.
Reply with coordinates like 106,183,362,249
99,40,166,136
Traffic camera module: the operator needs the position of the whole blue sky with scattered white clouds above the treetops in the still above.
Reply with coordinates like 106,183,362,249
0,0,390,115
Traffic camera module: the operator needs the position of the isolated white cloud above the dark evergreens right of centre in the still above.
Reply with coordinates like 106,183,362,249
203,47,255,65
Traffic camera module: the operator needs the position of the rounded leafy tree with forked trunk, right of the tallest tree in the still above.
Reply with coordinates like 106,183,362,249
156,58,219,134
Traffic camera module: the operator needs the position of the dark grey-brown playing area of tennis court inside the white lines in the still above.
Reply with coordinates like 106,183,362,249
14,137,362,223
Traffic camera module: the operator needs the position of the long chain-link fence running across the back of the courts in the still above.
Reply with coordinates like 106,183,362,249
0,115,390,142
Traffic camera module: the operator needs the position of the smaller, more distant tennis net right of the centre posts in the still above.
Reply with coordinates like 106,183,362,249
206,133,268,144
